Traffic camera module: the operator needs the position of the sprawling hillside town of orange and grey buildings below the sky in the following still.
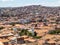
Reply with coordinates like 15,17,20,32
0,5,60,45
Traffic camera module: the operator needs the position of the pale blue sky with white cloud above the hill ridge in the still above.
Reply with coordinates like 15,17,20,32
0,0,60,7
